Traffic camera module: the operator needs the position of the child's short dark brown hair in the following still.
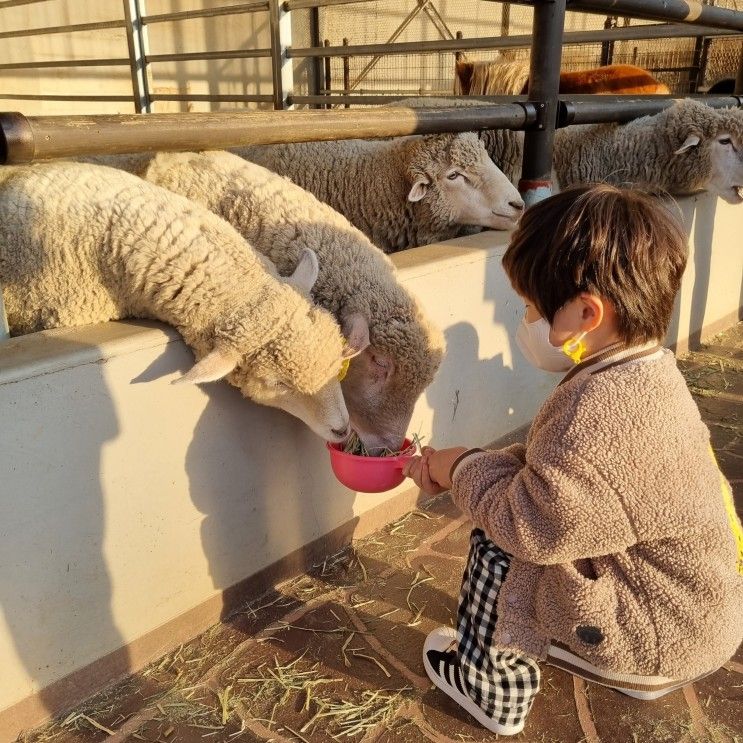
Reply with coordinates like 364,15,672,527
503,184,687,344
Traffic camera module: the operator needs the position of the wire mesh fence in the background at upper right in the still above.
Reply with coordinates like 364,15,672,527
316,0,743,101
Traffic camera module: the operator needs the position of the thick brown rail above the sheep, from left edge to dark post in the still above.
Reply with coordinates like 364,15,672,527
0,103,536,163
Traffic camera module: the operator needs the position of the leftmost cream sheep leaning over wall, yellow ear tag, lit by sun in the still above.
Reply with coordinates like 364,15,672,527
0,162,362,442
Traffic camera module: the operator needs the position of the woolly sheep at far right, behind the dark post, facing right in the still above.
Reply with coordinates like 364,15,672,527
389,98,743,204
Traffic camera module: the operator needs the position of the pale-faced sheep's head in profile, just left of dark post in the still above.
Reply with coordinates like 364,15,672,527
408,132,524,230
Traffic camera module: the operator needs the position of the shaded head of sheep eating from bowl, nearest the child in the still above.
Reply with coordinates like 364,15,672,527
342,302,444,451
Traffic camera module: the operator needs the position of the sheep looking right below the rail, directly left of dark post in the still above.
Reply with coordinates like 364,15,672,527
233,132,524,253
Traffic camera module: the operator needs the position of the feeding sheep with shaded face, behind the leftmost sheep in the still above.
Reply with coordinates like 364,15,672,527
132,152,444,451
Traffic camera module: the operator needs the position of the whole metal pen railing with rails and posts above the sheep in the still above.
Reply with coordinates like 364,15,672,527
0,0,743,342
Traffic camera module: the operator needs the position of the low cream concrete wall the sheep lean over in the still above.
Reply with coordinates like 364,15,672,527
0,196,743,741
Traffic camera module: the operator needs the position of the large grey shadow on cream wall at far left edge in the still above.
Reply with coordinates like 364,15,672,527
0,339,130,716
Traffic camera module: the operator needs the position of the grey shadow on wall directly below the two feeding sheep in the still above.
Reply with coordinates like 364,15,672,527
185,384,358,618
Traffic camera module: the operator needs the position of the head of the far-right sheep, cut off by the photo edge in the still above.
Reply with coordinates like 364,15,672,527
666,101,743,204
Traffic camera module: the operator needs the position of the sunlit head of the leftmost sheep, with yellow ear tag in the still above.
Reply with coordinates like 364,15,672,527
176,251,360,442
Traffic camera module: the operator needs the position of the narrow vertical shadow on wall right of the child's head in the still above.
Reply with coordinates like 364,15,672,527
666,192,720,351
